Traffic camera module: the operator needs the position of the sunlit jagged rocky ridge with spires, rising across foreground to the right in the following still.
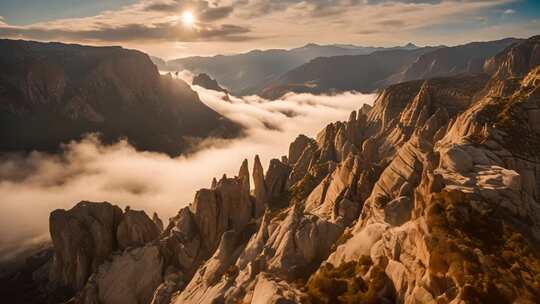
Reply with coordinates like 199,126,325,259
7,36,540,304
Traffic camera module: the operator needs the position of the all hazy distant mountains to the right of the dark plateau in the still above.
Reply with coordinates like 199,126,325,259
153,38,519,99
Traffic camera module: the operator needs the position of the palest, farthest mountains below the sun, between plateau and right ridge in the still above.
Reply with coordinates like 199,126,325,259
153,43,417,95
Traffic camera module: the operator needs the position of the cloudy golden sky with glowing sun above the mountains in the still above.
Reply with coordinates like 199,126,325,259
0,0,540,59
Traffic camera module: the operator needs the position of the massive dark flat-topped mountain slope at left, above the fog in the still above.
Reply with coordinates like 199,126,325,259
0,40,239,155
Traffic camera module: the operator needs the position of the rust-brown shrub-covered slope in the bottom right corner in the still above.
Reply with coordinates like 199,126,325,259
427,191,540,303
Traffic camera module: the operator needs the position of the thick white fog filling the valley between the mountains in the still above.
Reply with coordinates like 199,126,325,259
0,81,374,261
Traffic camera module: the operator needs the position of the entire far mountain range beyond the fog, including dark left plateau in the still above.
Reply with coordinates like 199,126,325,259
0,38,519,155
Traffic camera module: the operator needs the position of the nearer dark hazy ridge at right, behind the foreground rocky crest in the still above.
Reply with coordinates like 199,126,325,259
261,38,518,98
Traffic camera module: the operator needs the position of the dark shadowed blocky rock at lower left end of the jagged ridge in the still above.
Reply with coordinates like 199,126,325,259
49,201,159,291
